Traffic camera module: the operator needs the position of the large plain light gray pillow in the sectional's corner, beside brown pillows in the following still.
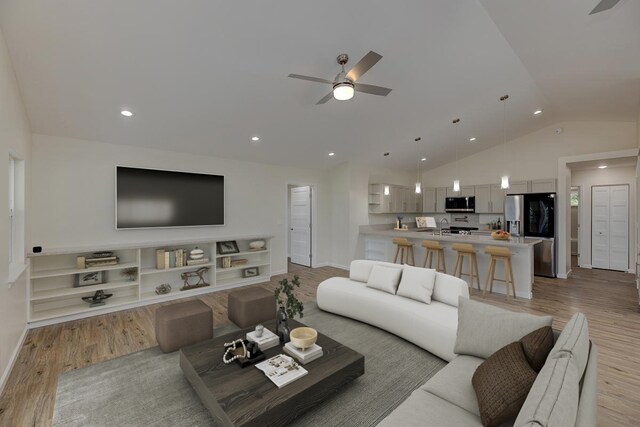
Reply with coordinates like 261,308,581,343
453,297,553,359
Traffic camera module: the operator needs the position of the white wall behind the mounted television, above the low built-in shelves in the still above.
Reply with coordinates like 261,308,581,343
31,134,331,272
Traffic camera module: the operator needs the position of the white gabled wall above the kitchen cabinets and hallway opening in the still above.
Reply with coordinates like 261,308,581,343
422,122,638,187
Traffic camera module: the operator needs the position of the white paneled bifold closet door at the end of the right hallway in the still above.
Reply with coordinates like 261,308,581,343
591,185,629,271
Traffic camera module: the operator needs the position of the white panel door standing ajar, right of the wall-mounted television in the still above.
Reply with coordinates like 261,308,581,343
289,186,311,267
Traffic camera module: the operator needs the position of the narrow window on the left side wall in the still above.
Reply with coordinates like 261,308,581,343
8,153,25,283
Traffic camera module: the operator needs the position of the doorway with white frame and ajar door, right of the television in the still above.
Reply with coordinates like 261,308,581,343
287,185,313,270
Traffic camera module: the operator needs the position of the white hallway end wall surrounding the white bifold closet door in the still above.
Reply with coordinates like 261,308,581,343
571,166,638,269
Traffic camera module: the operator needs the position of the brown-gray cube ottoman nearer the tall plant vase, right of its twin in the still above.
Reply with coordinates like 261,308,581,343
227,288,276,328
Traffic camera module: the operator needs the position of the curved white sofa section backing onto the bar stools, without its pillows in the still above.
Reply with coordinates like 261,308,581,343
317,260,469,361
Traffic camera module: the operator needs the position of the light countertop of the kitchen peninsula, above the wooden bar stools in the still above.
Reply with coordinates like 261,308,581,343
360,226,542,247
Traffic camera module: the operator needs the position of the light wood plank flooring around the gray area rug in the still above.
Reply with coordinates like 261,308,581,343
0,265,640,426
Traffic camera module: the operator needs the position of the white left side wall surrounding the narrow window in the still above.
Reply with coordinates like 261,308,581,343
0,27,31,388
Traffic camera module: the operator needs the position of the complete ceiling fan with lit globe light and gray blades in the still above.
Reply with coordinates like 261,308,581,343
289,51,391,105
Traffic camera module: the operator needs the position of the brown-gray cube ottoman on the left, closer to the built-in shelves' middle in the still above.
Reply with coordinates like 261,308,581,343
156,300,213,353
